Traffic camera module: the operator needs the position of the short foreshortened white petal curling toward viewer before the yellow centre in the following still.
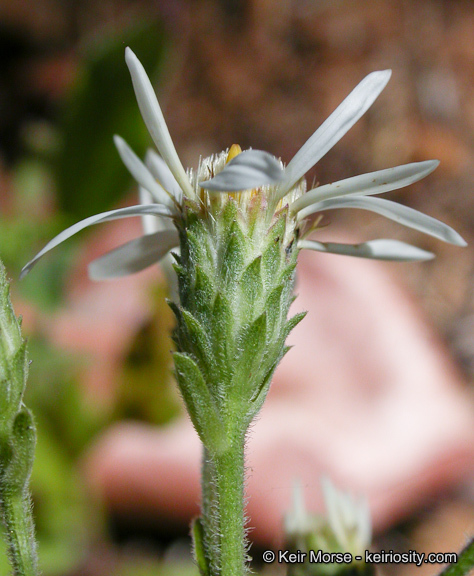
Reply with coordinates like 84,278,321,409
199,150,284,192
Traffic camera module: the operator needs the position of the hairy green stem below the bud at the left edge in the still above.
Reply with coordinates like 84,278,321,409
0,489,39,576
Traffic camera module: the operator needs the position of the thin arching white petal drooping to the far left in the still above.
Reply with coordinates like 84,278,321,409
20,204,173,279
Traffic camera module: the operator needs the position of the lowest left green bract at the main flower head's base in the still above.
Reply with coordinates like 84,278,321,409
173,352,228,453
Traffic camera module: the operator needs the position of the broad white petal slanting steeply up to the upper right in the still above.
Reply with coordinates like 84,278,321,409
278,70,392,198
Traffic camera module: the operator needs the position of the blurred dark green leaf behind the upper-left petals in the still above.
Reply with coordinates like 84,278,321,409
55,18,167,219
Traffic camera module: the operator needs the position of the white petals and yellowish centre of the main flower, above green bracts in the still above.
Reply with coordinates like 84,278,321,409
22,48,466,279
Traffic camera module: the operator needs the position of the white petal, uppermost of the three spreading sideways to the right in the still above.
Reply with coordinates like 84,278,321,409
290,160,439,213
